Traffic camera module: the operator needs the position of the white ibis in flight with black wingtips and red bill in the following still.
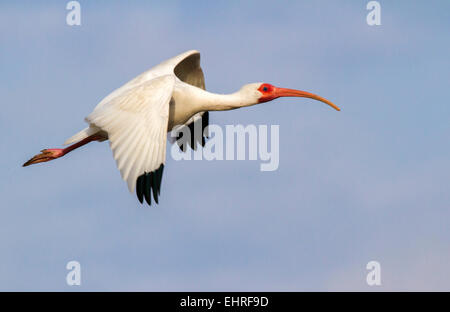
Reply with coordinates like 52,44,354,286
23,50,340,205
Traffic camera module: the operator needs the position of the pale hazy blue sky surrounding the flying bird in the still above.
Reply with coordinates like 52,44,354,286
0,0,450,291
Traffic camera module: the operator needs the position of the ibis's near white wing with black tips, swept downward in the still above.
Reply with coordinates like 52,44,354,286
86,75,175,204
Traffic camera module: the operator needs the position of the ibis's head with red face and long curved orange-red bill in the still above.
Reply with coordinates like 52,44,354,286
241,82,341,111
